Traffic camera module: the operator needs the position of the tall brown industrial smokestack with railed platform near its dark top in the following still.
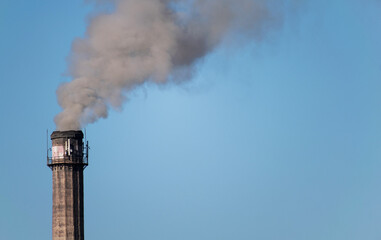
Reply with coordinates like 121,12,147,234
47,131,88,240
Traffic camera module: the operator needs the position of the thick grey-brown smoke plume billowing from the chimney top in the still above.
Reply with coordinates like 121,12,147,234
54,0,284,130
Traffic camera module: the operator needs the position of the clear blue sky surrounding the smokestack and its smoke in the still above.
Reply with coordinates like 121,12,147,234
0,0,381,240
